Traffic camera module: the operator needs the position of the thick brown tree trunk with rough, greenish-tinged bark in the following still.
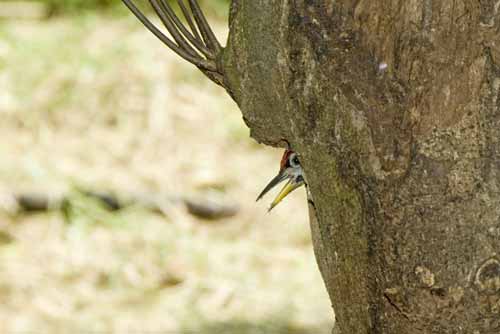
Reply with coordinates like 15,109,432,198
222,0,500,334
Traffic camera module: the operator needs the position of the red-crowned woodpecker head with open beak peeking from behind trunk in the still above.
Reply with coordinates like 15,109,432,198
257,150,305,211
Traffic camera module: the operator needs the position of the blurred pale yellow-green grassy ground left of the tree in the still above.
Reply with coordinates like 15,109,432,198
0,0,332,334
